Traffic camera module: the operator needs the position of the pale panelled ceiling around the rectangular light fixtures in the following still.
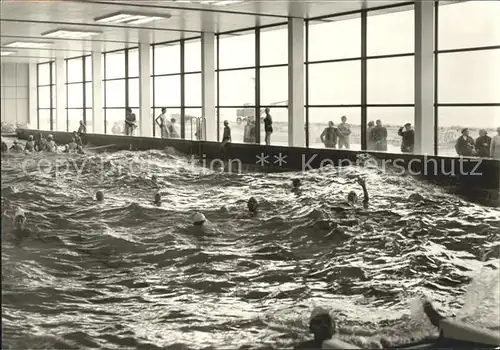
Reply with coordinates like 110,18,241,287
0,0,403,60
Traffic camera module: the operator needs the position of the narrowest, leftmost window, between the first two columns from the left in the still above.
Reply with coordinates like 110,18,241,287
37,62,56,130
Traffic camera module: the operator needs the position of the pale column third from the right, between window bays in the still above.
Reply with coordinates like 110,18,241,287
201,33,217,141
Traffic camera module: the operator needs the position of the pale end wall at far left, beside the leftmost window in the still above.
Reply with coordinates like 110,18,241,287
0,63,29,125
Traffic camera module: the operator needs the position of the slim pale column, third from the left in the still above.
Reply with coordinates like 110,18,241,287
92,50,104,134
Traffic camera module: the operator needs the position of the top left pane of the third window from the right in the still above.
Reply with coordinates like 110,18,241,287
219,30,255,69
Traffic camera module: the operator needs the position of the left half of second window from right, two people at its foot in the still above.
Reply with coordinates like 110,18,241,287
305,14,362,149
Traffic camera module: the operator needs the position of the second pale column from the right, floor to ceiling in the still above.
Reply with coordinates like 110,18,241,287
288,18,305,147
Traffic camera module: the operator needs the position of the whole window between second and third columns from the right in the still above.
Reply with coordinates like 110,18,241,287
216,25,288,145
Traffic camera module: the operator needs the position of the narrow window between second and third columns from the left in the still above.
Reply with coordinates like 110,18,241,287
66,56,92,132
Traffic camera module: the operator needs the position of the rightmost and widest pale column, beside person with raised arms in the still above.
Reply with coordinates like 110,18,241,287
415,1,435,154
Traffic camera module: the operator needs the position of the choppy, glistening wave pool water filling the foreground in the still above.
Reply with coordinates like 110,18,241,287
2,151,500,349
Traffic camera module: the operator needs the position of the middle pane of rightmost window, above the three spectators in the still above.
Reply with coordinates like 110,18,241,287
438,50,500,103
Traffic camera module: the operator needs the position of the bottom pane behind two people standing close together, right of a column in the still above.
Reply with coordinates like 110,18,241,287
309,107,361,150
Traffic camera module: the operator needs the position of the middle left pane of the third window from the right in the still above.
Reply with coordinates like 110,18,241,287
219,69,255,106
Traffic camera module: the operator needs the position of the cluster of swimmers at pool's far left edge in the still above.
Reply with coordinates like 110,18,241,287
2,131,84,154
